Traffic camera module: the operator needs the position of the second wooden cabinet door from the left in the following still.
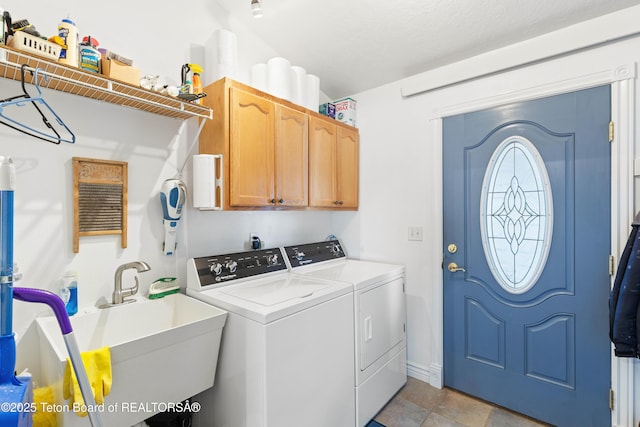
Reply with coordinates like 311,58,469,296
275,104,309,206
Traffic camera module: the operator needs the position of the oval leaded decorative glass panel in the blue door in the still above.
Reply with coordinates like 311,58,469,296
480,136,553,293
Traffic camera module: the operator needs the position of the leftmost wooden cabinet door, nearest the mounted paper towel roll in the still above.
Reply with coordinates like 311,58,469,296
229,88,275,207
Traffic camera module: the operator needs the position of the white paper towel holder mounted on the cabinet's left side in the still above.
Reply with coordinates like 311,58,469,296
193,154,223,211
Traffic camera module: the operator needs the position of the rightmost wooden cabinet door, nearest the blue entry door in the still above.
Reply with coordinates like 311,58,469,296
336,127,359,209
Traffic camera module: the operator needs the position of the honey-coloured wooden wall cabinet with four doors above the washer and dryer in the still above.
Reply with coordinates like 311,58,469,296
200,78,358,210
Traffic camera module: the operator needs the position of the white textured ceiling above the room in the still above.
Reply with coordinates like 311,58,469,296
218,0,640,99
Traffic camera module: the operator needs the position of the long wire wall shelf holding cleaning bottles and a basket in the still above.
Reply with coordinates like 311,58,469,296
0,46,213,120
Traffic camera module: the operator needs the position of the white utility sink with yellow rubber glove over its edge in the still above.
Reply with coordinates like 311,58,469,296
36,294,227,427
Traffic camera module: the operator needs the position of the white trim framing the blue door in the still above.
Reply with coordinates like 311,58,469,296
429,63,640,427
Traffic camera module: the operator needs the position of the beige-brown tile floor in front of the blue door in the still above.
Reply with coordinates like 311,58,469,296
375,377,549,427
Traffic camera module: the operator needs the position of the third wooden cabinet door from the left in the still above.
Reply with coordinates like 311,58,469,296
309,117,337,207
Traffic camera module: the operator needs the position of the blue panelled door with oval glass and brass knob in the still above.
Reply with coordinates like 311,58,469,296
443,86,611,427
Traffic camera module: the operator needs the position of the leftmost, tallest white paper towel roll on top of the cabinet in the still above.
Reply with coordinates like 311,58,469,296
203,29,238,85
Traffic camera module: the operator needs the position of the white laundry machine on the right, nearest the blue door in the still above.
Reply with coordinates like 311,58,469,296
284,240,407,427
